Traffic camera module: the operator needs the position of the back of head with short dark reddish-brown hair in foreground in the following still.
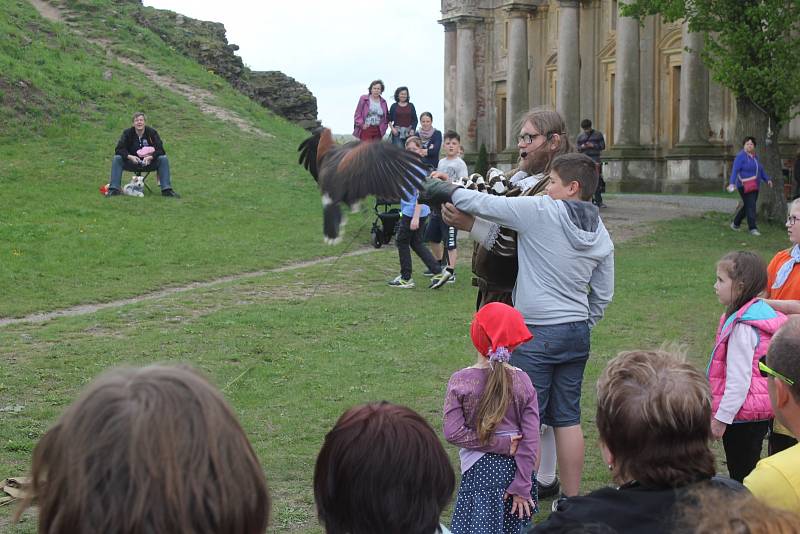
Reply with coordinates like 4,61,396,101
314,402,456,534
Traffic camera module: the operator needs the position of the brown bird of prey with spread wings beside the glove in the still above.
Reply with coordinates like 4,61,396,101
297,128,427,245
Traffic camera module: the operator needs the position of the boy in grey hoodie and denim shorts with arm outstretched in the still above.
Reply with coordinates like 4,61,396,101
421,152,614,497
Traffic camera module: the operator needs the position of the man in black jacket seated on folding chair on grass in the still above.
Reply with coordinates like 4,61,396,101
106,111,179,198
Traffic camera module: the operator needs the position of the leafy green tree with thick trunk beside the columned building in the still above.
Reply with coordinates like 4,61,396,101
620,0,800,222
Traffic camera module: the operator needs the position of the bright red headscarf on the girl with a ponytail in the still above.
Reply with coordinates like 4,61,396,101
470,302,533,361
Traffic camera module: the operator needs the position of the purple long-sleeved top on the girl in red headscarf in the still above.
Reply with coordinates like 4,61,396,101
443,367,539,496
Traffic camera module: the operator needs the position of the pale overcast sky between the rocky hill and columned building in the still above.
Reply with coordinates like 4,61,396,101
144,0,444,133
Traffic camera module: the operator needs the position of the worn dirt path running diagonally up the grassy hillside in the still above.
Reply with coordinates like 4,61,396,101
28,0,275,139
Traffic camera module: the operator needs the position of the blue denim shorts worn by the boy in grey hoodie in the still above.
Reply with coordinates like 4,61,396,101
511,321,590,427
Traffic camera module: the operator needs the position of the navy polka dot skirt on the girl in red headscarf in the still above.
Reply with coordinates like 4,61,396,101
450,454,539,534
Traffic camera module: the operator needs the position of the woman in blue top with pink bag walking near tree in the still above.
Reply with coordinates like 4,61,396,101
728,137,772,236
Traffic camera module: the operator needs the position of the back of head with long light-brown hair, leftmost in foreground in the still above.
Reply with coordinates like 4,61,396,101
17,365,270,534
